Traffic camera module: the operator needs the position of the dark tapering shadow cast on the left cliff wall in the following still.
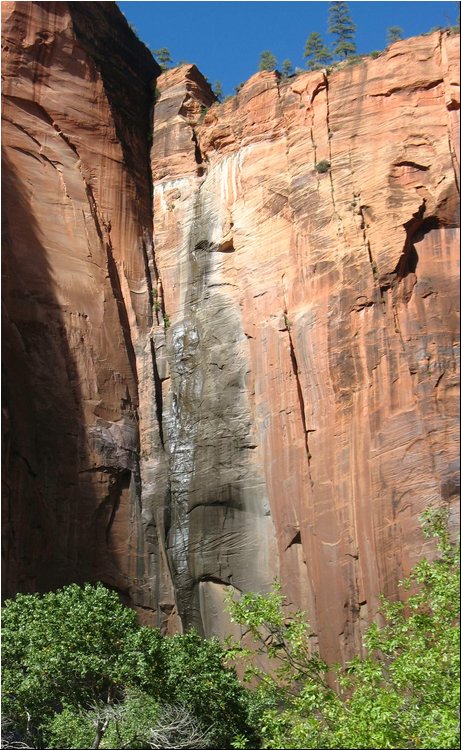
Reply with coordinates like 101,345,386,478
2,149,120,597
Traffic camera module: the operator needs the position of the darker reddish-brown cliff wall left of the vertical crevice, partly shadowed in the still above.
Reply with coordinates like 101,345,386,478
2,2,159,616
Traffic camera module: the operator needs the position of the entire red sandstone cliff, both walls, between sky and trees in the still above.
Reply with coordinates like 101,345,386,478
2,3,459,659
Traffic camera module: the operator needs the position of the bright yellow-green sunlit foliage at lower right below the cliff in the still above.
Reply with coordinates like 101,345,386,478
228,509,460,748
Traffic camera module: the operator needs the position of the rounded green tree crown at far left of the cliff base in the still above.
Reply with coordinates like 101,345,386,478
2,584,141,729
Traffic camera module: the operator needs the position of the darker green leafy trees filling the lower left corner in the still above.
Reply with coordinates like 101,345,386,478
2,584,252,747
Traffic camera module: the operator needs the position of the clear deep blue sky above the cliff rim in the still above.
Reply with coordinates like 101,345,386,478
118,0,459,95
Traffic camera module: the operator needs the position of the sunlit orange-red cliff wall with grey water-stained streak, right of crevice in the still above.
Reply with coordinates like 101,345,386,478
152,34,459,659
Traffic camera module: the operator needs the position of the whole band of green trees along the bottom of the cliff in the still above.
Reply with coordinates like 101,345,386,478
2,509,460,749
